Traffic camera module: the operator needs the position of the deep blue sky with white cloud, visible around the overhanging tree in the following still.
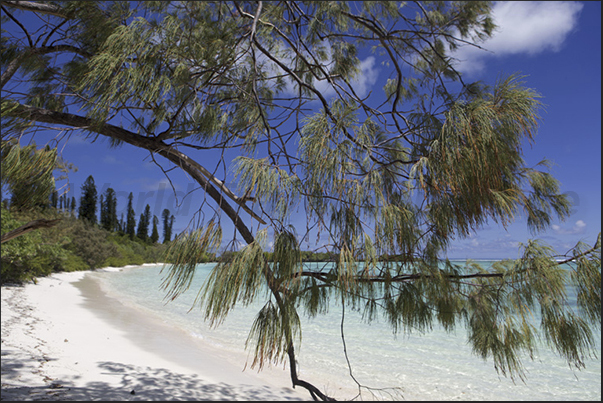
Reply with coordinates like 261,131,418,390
2,1,601,259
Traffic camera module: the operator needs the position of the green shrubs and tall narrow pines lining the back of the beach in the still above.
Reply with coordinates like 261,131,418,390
0,140,179,283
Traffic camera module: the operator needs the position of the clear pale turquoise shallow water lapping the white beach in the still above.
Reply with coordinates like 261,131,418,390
91,264,601,401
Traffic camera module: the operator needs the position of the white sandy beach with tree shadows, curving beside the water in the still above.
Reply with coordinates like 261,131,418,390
1,272,309,401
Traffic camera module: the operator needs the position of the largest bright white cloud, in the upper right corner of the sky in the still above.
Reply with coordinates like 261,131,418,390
453,1,583,73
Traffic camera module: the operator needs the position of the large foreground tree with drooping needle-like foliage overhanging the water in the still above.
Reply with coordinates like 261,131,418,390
1,1,601,400
